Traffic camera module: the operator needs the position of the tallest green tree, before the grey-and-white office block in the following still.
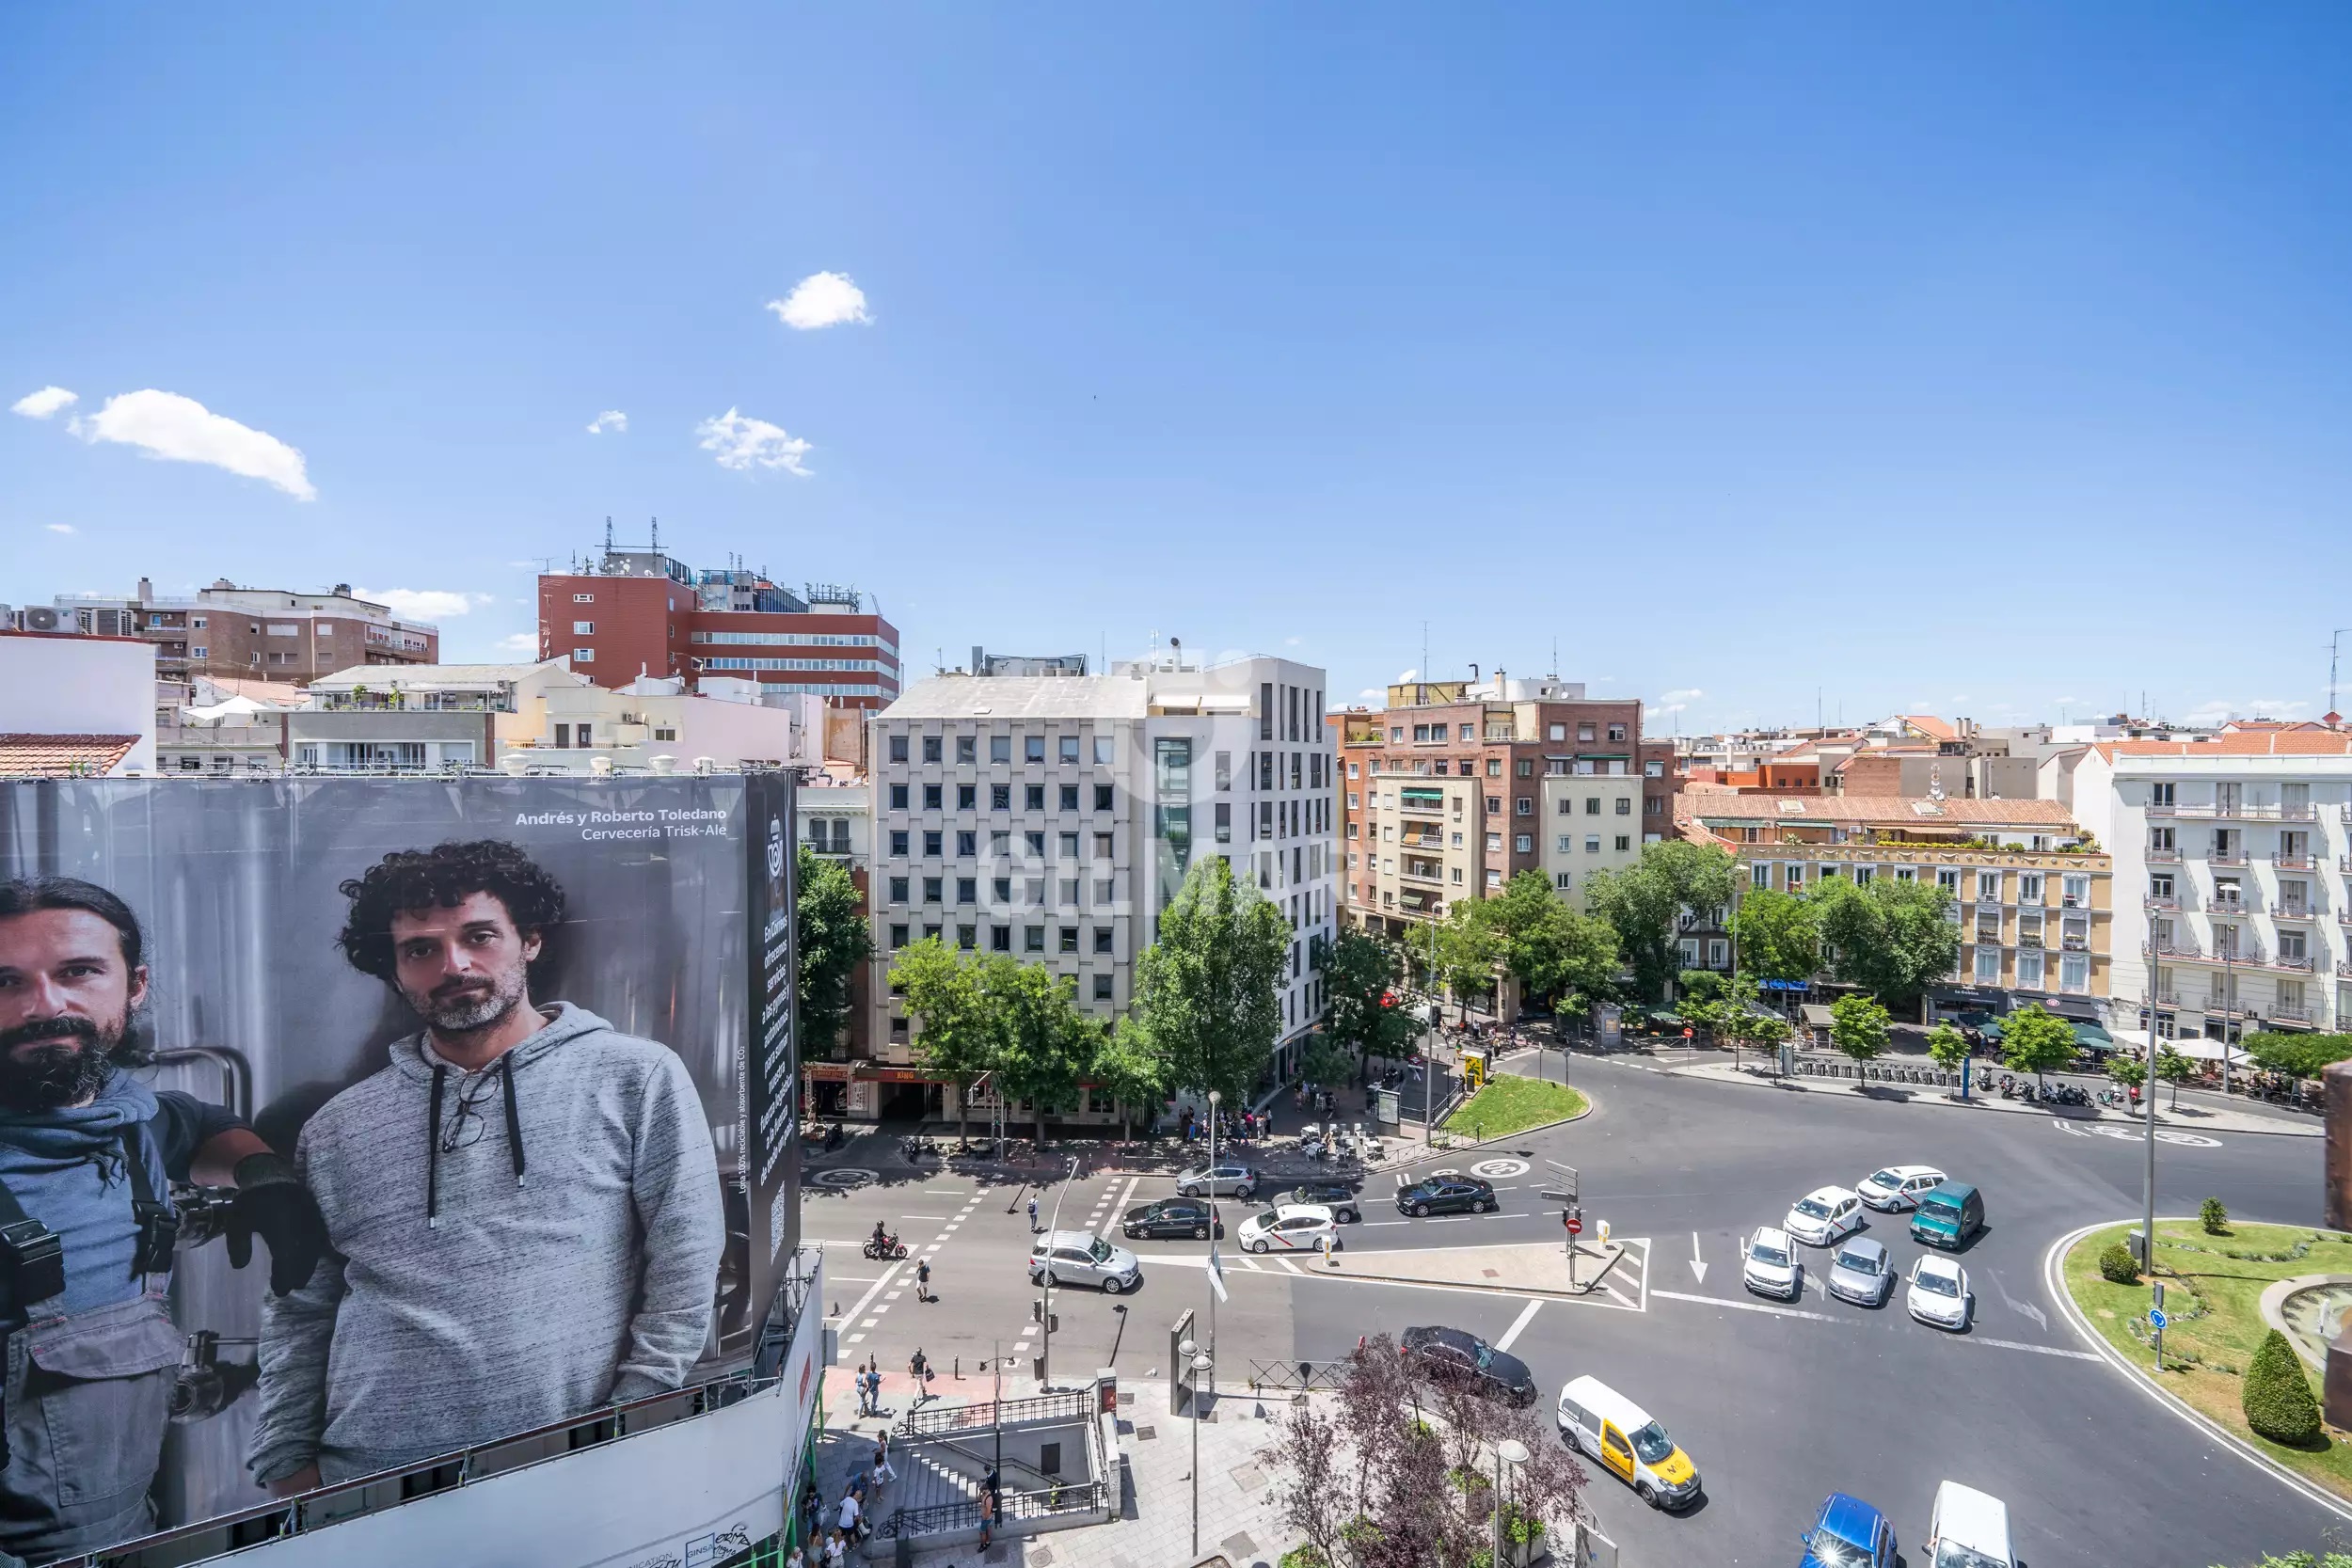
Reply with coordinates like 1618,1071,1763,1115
1127,856,1292,1105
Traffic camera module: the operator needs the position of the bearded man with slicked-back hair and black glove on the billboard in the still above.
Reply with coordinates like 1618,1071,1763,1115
0,877,325,1563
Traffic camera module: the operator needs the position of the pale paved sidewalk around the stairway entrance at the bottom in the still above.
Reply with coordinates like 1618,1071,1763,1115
818,1369,1322,1568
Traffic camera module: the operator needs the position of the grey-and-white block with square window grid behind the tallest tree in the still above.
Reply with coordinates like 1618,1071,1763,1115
866,654,1336,1121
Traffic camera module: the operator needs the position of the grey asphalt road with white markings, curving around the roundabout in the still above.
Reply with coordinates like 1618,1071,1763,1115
803,1067,2352,1568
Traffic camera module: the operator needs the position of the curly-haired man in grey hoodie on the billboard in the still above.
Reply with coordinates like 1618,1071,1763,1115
247,839,727,1496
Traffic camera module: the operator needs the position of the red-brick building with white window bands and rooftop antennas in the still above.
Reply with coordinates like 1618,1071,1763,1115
539,540,903,710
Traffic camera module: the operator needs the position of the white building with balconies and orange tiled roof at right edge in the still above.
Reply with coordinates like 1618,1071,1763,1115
2074,729,2352,1039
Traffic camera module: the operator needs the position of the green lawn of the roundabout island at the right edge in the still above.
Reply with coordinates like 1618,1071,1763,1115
2058,1220,2352,1497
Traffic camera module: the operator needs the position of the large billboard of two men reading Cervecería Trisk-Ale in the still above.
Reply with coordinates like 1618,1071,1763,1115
0,773,798,1563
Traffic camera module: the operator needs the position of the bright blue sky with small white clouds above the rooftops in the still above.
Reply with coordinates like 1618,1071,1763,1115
0,2,2352,729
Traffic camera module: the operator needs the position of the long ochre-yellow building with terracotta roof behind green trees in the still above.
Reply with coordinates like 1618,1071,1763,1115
1679,790,2120,1022
